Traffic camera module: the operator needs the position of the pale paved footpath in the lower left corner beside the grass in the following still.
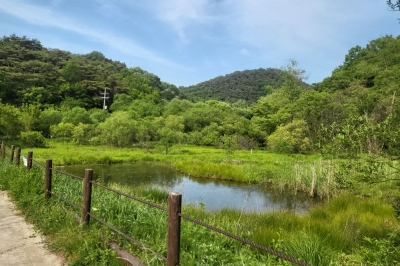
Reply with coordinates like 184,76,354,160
0,191,65,266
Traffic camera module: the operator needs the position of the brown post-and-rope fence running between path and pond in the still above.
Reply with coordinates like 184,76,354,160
0,142,308,266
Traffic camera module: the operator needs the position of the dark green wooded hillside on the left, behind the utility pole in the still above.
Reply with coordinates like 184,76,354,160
0,35,178,108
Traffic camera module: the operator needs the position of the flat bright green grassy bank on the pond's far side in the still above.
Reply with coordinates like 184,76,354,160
17,141,337,197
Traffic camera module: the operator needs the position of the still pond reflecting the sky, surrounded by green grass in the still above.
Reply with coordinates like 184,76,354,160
65,163,319,213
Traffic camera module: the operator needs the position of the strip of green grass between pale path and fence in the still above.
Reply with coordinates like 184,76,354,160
0,159,122,265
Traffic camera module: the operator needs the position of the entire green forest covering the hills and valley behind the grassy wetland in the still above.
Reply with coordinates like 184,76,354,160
0,35,400,168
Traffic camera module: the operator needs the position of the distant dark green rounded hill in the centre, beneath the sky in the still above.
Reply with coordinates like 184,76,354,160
180,68,283,103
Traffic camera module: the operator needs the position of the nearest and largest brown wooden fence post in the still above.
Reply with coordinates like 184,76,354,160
167,192,182,266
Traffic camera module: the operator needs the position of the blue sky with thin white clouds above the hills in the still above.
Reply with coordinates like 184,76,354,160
0,0,400,86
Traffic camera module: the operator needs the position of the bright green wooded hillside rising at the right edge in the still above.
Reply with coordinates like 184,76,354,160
313,36,400,136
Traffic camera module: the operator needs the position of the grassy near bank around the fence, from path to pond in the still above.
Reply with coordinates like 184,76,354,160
0,160,400,265
